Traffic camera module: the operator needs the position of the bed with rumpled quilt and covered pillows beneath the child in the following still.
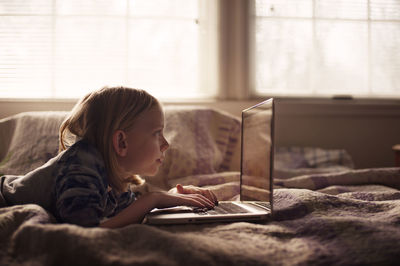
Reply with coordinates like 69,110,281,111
0,106,400,265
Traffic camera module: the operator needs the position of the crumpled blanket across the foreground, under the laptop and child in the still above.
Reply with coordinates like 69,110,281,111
0,168,400,265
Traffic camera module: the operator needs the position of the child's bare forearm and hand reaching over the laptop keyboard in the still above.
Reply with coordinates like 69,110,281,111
100,192,214,228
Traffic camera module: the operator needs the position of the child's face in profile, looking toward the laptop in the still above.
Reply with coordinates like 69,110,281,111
119,105,169,176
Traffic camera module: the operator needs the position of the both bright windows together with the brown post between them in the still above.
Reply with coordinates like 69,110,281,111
0,0,400,99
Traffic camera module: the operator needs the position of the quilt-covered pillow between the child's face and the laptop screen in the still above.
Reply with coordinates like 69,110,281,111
144,106,240,190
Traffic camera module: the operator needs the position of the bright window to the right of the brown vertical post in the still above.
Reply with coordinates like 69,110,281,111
253,0,400,97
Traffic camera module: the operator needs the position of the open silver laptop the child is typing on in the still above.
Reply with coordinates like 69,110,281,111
145,98,275,225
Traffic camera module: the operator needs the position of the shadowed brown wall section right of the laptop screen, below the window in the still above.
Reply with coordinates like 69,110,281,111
276,100,400,168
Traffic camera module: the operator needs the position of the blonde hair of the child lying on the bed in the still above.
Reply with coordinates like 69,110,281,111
59,87,159,192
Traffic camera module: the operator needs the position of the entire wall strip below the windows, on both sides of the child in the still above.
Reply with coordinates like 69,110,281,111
0,99,400,168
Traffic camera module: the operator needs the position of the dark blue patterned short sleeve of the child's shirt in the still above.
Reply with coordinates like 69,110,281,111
56,167,107,227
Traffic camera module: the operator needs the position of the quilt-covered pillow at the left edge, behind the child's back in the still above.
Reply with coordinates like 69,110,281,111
0,112,67,175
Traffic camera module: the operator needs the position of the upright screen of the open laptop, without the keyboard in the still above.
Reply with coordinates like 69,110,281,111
240,99,274,205
